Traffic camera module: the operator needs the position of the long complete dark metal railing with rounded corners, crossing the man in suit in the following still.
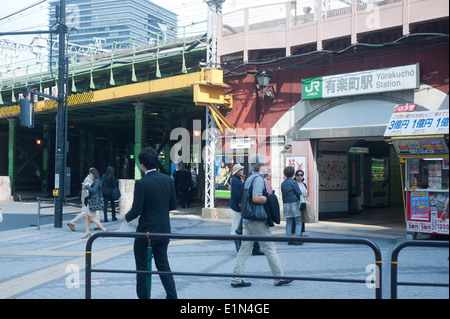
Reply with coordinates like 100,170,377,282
85,232,382,299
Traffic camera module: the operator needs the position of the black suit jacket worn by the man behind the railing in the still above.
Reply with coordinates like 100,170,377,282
125,171,177,233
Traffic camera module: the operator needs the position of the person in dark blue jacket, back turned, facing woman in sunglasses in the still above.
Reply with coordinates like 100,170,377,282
281,166,303,245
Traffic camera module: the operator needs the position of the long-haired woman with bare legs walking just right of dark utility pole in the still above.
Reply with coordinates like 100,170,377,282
83,167,108,238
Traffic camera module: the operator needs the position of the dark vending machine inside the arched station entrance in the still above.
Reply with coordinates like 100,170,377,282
364,156,389,207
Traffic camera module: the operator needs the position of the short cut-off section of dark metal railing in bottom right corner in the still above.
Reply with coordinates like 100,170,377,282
391,240,449,299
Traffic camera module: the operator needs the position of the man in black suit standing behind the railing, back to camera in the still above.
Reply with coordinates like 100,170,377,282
122,147,177,299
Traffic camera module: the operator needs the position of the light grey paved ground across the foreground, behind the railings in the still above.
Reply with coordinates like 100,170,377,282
0,203,449,311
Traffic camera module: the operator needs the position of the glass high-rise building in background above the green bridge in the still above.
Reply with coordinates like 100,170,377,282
49,0,177,48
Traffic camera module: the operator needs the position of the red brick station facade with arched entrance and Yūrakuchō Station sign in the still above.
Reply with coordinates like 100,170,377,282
217,24,449,219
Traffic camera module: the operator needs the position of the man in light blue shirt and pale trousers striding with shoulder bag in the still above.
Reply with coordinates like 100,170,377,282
231,155,292,288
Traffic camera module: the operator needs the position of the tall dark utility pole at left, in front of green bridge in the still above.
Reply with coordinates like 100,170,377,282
54,0,67,228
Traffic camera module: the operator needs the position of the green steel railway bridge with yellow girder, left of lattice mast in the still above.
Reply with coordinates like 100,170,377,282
0,23,236,193
